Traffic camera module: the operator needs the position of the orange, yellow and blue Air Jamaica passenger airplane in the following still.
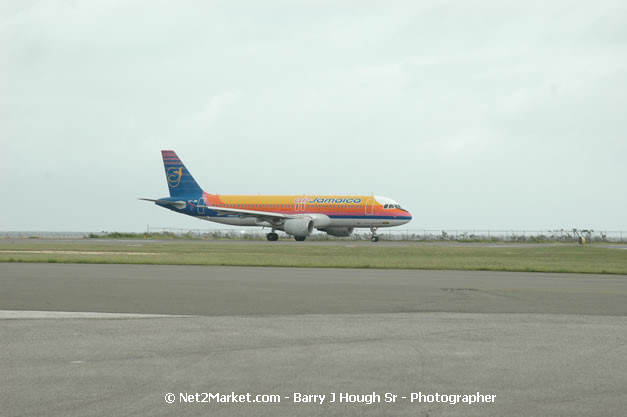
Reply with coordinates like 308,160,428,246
140,150,411,242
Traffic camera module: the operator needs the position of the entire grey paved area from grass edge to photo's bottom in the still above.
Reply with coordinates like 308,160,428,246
0,264,627,416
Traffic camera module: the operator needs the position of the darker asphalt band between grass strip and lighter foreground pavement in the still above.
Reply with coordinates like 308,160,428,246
0,263,627,316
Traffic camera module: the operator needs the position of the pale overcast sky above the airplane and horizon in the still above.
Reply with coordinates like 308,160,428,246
0,0,627,231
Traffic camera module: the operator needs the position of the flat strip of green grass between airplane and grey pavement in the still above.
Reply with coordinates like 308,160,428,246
0,240,627,274
